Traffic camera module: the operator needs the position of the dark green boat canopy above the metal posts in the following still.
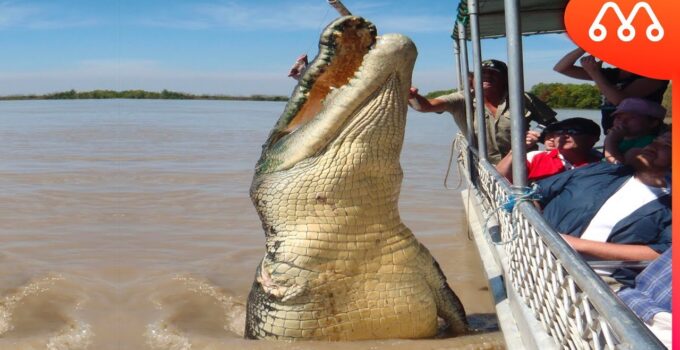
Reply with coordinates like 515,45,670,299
451,0,569,40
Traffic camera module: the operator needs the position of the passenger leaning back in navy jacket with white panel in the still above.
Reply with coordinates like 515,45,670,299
537,132,671,283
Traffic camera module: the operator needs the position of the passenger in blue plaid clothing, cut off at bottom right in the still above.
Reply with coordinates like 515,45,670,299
618,247,673,349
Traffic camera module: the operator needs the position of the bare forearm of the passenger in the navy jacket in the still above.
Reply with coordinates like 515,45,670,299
562,234,660,260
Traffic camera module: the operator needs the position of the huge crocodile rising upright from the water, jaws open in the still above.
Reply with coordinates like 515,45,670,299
244,16,468,341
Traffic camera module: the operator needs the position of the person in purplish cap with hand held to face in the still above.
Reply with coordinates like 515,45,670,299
604,97,666,163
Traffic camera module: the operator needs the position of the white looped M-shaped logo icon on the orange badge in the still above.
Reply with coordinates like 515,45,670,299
588,1,664,42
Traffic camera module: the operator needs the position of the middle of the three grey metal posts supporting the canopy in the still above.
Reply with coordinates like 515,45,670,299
466,0,488,160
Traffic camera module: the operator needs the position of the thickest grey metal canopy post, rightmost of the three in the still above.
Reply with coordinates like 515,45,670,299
504,0,527,191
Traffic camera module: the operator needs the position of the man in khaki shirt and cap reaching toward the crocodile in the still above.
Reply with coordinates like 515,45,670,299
409,60,556,164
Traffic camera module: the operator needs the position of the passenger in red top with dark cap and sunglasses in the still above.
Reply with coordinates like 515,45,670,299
496,118,602,182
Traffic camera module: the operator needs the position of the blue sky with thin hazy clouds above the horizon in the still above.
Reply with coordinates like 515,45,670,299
0,0,576,95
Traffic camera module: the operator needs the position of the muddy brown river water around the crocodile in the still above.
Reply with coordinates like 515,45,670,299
0,100,503,350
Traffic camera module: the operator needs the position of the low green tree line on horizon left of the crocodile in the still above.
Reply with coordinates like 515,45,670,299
0,90,288,101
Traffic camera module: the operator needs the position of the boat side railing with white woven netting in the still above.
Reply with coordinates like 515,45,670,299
455,134,663,349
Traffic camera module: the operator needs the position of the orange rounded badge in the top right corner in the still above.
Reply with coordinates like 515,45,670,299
564,0,680,79
